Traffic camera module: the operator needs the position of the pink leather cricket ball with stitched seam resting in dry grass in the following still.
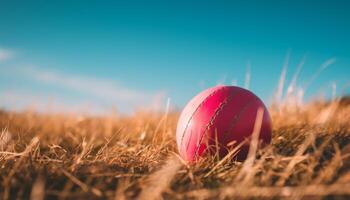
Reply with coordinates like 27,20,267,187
176,85,271,161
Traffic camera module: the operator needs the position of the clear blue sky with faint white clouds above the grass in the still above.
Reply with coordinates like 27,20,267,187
0,1,350,112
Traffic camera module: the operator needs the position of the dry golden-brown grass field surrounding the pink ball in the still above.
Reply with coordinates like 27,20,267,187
0,98,350,200
